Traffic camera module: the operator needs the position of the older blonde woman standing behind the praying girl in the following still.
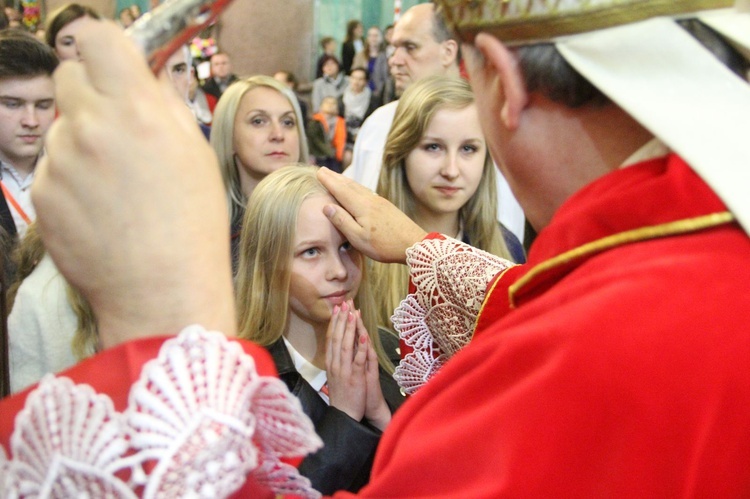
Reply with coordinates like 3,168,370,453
210,75,309,269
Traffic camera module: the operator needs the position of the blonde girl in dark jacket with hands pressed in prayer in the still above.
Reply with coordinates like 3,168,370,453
237,165,403,494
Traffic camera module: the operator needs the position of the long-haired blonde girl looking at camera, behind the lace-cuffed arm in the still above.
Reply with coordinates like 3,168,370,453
372,76,525,332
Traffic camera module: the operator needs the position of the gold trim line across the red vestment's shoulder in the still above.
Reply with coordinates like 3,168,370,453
508,211,734,308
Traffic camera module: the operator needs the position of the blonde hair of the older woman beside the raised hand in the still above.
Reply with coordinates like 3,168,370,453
210,75,309,223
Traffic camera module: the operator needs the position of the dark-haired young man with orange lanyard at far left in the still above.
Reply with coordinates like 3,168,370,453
0,30,58,237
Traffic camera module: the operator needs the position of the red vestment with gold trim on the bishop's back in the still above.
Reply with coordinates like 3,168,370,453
346,155,750,498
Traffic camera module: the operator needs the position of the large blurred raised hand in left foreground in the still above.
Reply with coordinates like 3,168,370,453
32,19,235,347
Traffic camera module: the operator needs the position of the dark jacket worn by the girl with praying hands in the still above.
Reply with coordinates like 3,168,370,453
266,339,404,495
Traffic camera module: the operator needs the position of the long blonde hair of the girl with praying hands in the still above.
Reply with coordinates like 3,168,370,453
237,164,393,373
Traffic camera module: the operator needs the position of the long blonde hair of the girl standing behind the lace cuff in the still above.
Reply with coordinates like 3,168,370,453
371,76,511,328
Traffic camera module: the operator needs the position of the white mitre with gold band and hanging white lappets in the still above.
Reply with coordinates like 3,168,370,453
436,0,750,232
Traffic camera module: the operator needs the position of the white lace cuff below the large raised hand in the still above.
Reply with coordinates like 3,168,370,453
0,326,322,498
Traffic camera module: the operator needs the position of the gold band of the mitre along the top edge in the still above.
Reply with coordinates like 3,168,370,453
436,0,734,45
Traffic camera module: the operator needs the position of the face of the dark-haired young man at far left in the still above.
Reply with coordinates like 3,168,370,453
0,75,55,167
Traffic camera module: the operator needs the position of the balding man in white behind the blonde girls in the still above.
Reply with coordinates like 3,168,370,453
344,3,524,241
